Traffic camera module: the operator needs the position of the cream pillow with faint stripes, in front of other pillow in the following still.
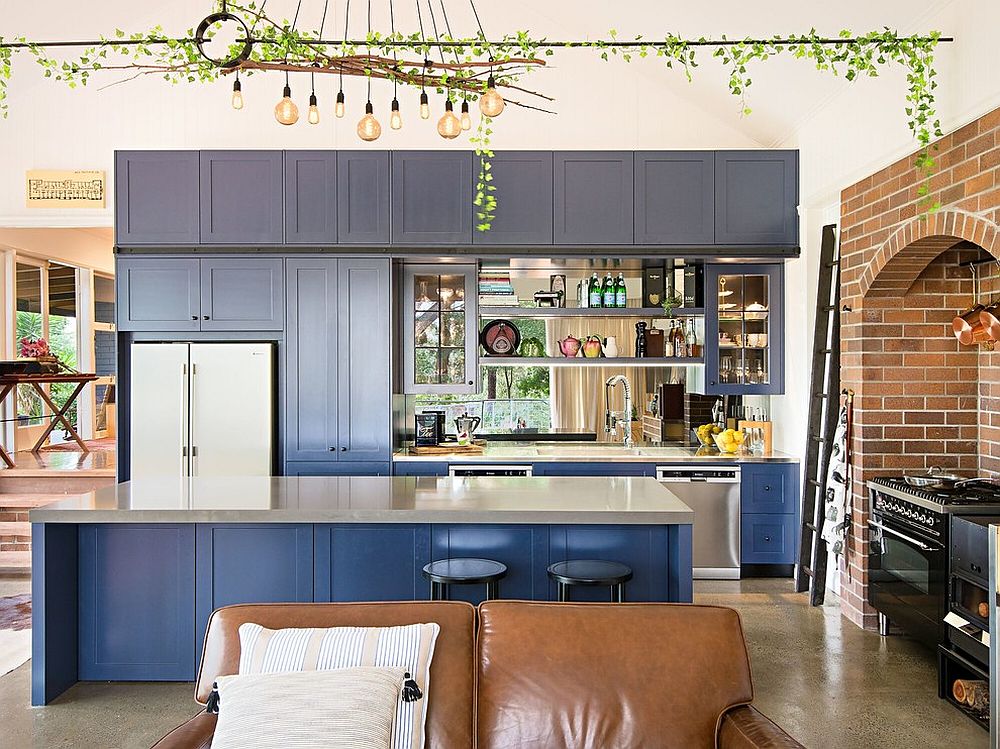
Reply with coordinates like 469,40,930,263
212,668,403,749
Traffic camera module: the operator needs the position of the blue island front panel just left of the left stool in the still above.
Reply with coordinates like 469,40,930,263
315,523,431,601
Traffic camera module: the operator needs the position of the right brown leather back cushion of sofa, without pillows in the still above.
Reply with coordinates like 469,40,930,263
477,601,753,749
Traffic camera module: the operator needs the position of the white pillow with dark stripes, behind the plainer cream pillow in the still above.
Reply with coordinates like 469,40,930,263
236,623,441,749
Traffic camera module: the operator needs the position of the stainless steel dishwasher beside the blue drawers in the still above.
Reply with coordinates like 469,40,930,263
656,466,740,580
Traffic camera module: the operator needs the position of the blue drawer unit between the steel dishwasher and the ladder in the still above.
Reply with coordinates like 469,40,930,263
740,463,799,567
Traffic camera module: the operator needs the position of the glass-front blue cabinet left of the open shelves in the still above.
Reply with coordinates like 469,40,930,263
403,263,479,393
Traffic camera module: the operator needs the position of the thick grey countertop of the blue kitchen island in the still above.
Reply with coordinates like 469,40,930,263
29,476,693,525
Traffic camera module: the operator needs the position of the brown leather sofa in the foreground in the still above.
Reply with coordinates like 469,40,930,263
154,601,802,749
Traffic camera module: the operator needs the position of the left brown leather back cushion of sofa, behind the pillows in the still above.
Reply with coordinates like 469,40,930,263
195,601,476,749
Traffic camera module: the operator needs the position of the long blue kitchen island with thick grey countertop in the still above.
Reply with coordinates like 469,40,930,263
30,477,693,705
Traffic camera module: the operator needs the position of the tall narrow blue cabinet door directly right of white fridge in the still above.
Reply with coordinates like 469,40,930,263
284,257,340,461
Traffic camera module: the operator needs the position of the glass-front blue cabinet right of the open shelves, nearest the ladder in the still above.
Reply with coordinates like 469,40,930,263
705,264,785,395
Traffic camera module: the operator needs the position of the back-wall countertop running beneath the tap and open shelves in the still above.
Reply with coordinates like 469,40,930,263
392,441,798,458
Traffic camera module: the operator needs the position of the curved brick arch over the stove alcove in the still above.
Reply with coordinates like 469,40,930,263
860,210,1000,298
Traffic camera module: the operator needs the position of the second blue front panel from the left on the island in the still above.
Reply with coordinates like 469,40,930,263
194,523,313,651
